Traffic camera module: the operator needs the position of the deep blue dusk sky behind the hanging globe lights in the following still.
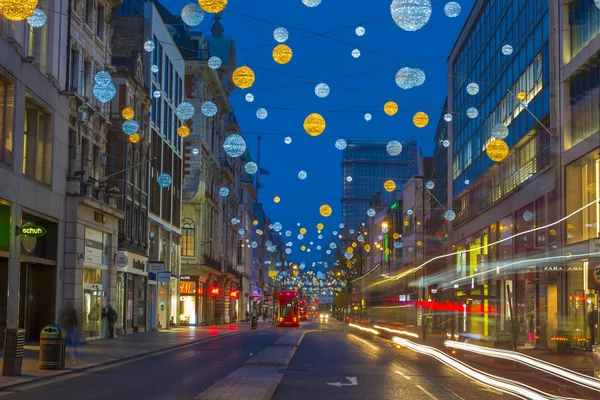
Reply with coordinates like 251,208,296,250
166,0,474,261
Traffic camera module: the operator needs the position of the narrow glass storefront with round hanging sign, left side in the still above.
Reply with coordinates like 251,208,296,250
116,252,148,334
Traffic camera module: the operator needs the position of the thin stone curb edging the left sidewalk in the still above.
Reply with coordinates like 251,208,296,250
0,328,262,395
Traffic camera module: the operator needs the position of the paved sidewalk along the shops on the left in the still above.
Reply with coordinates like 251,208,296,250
0,321,273,390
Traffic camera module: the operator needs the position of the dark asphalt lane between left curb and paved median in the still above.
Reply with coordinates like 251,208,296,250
0,329,287,400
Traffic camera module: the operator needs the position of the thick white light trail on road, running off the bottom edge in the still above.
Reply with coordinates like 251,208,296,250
392,337,584,400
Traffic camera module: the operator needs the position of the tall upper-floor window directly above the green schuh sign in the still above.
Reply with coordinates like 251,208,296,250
23,95,52,185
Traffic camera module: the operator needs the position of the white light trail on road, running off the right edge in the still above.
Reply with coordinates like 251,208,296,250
444,340,600,391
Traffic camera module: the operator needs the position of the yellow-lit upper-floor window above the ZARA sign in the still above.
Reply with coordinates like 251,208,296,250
565,150,600,244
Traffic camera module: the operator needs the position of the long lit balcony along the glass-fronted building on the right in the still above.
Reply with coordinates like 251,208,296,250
453,147,552,227
